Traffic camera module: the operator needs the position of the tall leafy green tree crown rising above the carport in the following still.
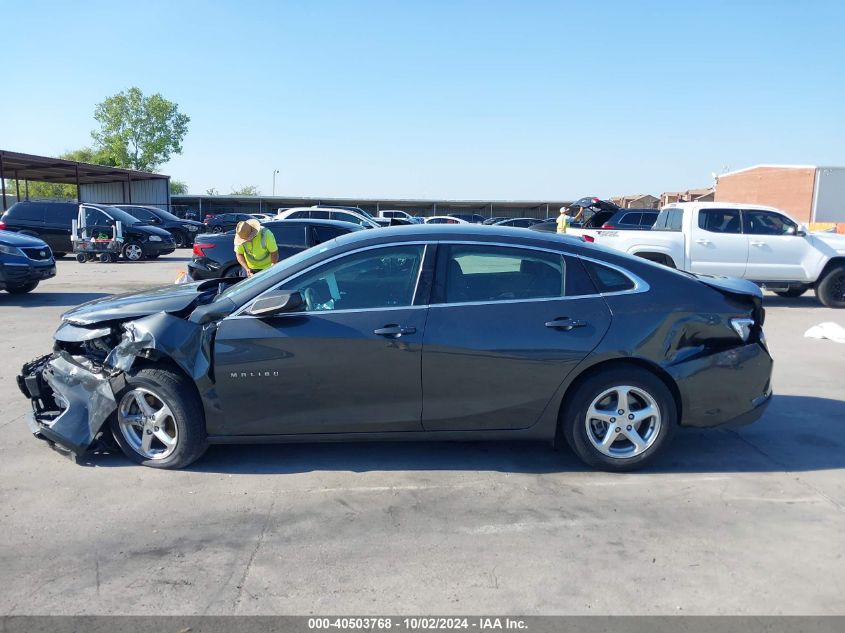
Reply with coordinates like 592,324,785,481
91,87,191,171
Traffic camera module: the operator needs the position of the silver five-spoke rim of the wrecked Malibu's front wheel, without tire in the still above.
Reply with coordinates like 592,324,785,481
117,387,179,460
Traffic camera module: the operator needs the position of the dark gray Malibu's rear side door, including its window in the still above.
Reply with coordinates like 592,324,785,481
422,244,610,431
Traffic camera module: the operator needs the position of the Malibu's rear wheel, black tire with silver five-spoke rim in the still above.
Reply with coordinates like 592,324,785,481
560,366,678,472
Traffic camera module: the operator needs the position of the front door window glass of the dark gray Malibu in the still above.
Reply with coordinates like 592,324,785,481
282,244,424,312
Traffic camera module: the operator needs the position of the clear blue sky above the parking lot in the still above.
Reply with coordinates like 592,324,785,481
0,0,845,200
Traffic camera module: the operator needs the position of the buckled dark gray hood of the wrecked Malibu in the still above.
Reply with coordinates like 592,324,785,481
62,280,218,325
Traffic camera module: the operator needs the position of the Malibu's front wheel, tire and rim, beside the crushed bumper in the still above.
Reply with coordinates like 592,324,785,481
110,367,208,469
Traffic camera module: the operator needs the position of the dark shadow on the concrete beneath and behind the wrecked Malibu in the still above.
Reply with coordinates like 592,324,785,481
80,396,845,475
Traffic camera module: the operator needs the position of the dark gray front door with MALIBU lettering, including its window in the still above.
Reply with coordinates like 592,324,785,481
209,244,428,435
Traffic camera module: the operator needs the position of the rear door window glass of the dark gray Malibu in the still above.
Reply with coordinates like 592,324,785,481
441,245,565,303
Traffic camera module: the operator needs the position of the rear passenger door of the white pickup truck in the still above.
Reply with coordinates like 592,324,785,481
687,208,748,277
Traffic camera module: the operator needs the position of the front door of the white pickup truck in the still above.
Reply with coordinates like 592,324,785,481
742,209,812,281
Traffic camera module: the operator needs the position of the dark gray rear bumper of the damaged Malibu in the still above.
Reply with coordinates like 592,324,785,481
667,343,774,427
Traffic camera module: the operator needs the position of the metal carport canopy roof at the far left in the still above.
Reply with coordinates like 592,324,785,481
0,150,170,210
